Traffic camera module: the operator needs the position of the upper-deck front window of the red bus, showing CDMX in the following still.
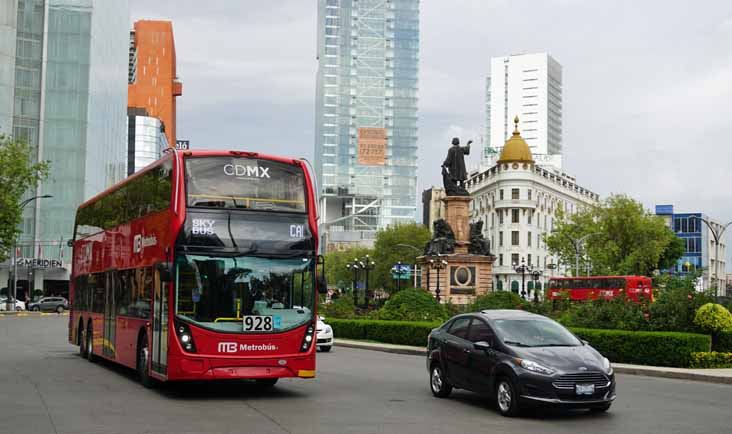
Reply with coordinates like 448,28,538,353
185,157,306,212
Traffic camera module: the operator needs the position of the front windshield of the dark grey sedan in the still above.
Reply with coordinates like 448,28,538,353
494,319,582,347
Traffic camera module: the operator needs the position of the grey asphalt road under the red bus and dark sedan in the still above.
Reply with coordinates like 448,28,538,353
0,316,732,434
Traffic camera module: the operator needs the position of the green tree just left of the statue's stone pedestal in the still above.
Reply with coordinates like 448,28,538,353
369,223,430,291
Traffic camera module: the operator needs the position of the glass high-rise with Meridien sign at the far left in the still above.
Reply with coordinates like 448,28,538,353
0,0,129,296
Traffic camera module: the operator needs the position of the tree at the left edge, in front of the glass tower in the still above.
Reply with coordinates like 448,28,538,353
0,134,49,262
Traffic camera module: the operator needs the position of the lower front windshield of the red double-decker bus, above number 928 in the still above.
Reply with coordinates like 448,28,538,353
176,255,315,332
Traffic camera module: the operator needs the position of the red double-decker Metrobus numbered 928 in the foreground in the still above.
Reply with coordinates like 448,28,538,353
69,151,326,386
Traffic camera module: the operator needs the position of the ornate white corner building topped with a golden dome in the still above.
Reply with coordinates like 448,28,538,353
466,117,599,299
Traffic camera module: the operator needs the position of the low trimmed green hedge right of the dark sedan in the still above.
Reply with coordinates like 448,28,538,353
571,328,711,368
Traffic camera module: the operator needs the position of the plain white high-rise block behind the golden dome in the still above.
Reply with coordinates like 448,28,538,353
483,53,562,169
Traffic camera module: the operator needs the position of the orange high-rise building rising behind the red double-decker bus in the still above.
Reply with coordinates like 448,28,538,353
127,20,183,147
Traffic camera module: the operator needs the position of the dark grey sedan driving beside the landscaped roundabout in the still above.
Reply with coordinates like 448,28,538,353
427,310,615,416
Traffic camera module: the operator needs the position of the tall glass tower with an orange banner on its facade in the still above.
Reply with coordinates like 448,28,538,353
315,0,419,250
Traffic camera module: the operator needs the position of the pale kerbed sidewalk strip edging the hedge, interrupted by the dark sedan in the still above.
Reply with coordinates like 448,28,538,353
334,339,732,384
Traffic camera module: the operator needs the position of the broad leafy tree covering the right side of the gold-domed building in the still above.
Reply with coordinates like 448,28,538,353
545,195,683,276
